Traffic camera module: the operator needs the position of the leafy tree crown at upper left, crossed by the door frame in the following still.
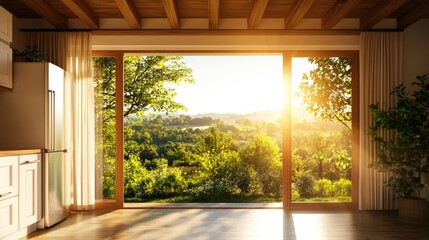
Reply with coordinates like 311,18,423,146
93,56,194,121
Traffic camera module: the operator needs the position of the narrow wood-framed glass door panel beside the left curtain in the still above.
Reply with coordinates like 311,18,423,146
93,52,123,208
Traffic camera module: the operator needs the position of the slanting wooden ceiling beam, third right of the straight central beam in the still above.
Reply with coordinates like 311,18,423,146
322,0,361,29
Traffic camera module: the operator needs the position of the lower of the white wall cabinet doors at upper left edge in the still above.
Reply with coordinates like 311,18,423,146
0,41,12,89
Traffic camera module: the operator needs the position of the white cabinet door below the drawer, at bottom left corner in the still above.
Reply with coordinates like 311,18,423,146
0,196,18,239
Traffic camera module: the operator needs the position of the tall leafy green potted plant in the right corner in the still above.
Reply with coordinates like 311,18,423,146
370,75,429,223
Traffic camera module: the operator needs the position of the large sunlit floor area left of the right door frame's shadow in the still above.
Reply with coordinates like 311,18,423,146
31,209,283,240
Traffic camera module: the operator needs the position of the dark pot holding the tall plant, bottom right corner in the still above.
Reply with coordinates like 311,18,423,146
398,198,429,224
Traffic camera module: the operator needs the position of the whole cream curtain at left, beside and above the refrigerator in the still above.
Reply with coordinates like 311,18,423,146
27,31,95,210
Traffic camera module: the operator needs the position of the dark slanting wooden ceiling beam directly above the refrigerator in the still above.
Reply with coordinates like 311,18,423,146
22,0,68,28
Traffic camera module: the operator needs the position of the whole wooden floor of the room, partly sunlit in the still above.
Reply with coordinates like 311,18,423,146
27,209,429,240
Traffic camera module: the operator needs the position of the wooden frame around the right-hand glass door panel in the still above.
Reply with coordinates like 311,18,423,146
283,50,360,210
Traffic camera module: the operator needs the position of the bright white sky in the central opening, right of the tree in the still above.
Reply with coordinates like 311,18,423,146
171,55,284,115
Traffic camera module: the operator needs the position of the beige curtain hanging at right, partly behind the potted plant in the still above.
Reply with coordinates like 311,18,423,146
359,32,403,210
